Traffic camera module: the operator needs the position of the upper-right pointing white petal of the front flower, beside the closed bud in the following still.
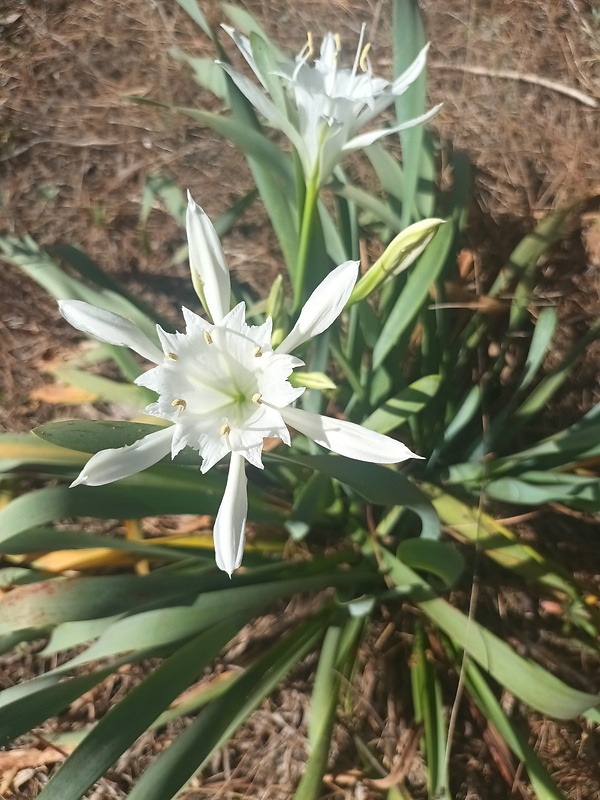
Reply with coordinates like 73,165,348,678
275,261,358,353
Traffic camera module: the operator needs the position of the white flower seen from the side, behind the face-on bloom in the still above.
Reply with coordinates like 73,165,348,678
221,25,440,186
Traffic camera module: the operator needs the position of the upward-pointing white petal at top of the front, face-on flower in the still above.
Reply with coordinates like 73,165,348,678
185,192,231,322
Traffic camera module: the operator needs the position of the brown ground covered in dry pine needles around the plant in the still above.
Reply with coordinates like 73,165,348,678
0,0,600,800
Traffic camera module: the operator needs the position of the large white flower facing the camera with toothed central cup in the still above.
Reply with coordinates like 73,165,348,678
60,197,420,575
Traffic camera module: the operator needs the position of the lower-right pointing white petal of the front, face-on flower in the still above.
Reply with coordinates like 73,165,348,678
280,408,419,464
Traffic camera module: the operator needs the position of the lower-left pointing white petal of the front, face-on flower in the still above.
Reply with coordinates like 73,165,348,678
71,426,175,486
